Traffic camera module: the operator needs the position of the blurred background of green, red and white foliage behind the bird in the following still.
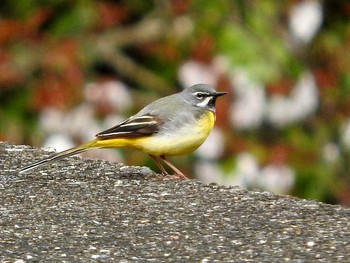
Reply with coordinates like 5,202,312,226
0,0,350,205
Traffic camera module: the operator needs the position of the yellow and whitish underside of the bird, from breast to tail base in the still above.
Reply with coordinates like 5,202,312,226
88,111,215,156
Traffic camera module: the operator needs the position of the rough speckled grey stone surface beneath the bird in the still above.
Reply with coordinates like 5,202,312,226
0,143,350,263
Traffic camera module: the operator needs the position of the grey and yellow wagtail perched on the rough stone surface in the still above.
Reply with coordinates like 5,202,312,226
19,84,227,179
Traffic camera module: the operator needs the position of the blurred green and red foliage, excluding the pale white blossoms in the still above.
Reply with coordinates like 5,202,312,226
0,0,350,204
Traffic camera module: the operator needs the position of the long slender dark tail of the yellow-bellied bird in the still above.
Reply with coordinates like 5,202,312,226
19,140,99,174
